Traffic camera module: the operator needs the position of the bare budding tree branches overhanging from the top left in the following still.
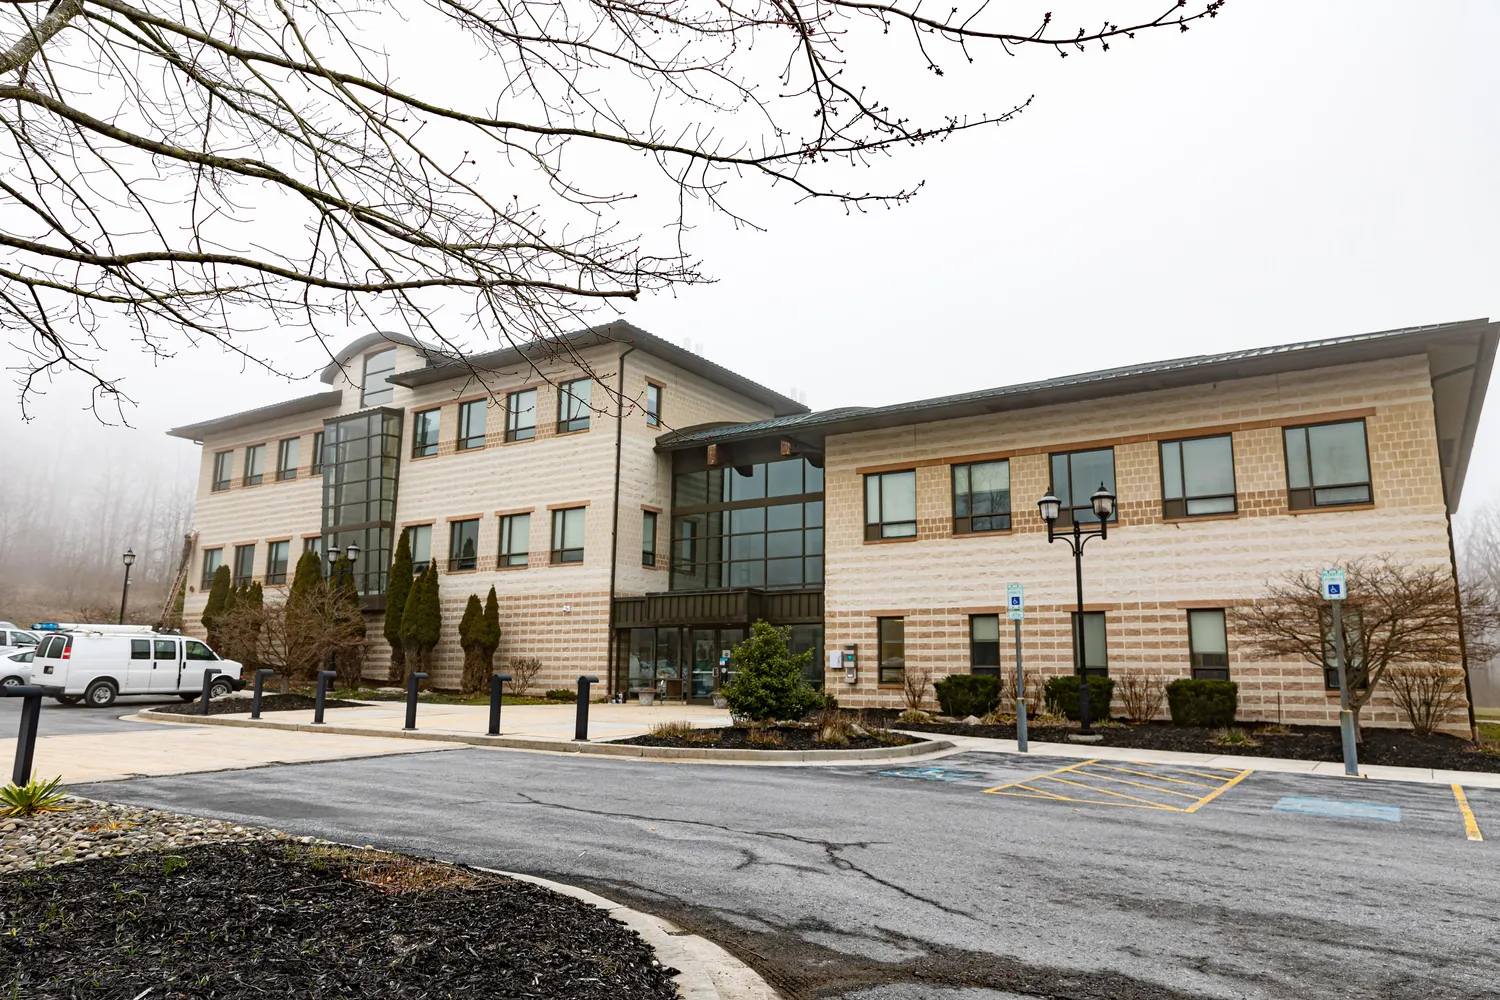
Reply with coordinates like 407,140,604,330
0,0,1223,405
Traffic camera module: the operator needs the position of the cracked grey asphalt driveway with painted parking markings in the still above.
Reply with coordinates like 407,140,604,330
80,748,1500,1000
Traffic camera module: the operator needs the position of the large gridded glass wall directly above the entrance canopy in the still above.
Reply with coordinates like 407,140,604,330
671,457,824,591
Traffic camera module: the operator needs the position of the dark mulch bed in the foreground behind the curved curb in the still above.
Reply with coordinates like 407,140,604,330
0,843,677,1000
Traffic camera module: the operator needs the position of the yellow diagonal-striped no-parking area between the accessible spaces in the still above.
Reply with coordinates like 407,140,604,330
986,759,1253,813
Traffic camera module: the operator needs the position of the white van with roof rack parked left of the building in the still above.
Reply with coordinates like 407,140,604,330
32,625,245,708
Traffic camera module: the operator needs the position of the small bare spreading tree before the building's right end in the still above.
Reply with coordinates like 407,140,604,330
1232,556,1500,733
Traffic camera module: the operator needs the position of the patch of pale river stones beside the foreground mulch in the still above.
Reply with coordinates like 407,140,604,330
0,796,298,874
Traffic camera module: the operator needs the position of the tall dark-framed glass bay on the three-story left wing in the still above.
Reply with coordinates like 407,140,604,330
323,411,401,594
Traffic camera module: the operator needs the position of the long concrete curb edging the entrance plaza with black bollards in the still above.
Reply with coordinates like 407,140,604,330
135,711,957,763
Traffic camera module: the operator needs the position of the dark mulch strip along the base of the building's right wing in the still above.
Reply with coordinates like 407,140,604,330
888,723,1500,772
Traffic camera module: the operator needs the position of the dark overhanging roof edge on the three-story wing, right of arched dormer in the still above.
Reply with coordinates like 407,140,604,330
386,319,809,417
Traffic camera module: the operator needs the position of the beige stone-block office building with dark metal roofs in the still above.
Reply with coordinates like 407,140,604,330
173,319,1500,724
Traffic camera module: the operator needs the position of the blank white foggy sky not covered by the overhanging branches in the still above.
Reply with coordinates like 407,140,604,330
3,0,1500,530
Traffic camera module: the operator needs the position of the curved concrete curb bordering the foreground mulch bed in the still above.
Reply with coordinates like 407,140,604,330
483,865,780,1000
